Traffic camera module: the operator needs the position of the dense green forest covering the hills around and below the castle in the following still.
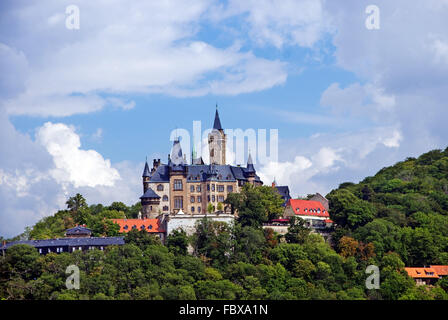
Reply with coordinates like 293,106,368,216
0,148,448,300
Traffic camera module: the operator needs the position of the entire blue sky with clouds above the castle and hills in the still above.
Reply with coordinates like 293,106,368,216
0,0,448,237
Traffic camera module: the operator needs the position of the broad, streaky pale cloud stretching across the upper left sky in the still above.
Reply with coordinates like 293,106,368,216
0,0,287,116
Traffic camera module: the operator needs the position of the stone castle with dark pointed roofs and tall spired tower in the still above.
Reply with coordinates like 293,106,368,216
140,108,263,219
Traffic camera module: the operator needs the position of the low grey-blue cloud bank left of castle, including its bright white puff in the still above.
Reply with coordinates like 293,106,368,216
0,114,143,237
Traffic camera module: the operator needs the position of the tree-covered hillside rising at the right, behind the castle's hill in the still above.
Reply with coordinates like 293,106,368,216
327,148,448,266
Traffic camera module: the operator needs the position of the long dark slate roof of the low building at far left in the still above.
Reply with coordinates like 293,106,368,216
1,237,124,249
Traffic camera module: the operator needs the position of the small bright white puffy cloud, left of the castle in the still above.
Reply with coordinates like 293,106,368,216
37,122,120,188
